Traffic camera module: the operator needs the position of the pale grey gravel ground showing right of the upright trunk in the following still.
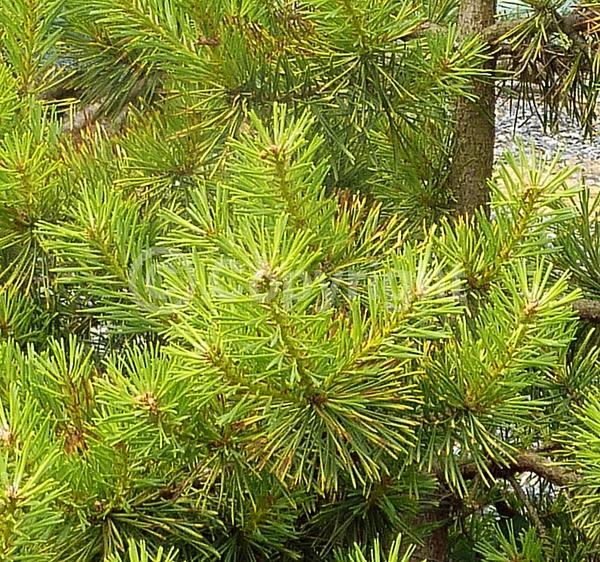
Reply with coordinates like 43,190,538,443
495,94,600,186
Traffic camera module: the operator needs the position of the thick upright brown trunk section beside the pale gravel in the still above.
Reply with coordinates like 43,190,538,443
449,0,496,214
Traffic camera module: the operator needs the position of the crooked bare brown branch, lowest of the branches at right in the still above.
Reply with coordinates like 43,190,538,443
461,452,579,486
